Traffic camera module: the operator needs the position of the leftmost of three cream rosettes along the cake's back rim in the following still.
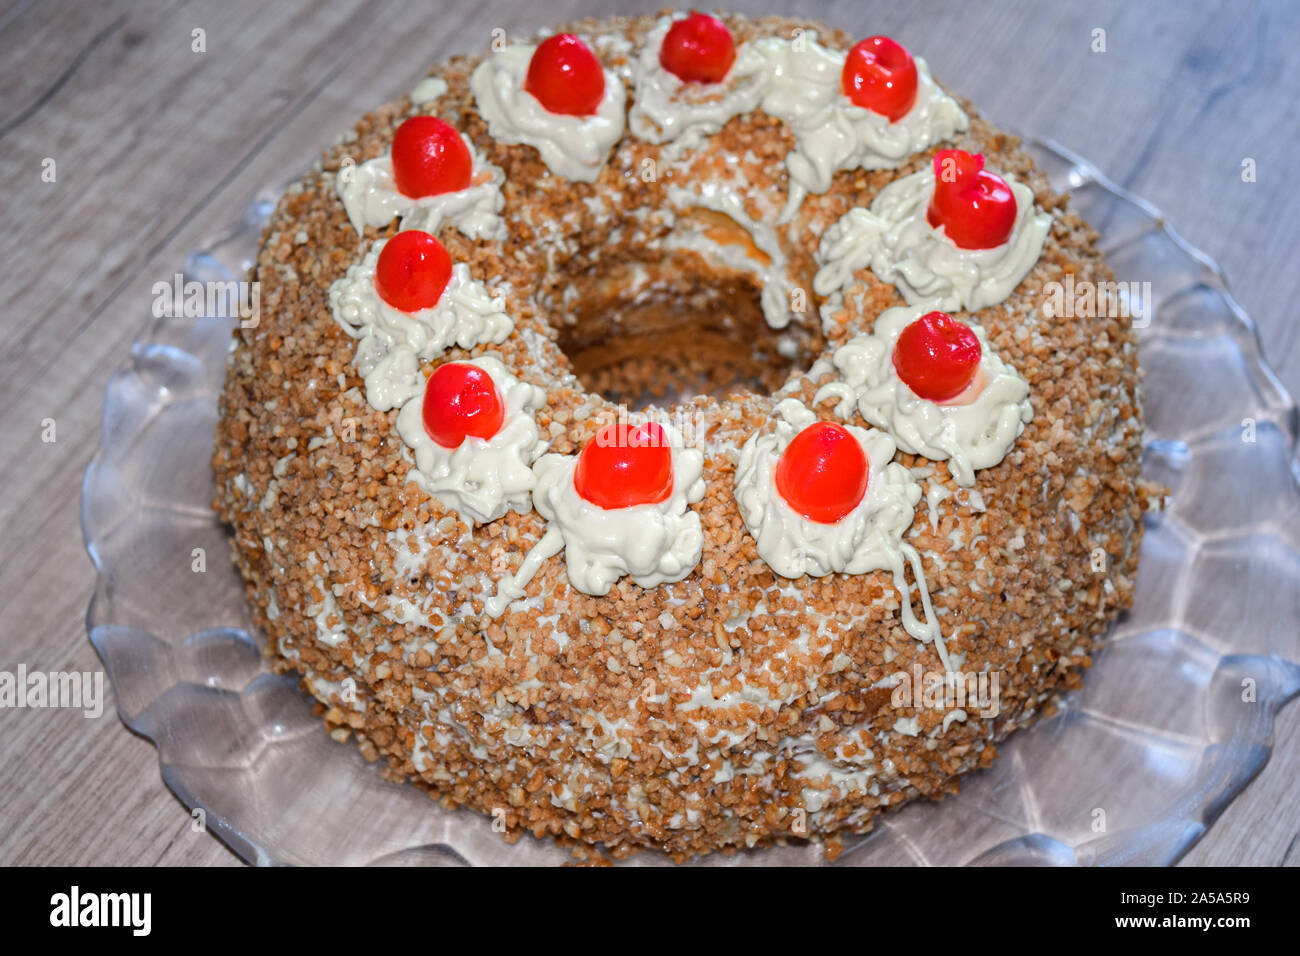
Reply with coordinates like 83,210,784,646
469,38,627,182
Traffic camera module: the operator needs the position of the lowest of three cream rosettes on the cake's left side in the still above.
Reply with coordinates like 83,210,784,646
398,355,546,524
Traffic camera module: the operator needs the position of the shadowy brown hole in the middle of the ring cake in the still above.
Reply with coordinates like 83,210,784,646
556,263,820,411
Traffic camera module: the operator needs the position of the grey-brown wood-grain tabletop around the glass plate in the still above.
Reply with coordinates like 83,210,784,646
0,0,1300,865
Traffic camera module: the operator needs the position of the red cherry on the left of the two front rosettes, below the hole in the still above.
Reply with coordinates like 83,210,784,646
573,421,672,511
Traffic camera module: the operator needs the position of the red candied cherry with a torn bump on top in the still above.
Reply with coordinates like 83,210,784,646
926,150,1017,248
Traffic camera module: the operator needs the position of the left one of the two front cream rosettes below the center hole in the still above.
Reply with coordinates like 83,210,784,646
533,425,705,594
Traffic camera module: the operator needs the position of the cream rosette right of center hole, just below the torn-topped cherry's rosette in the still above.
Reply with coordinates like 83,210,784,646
814,302,1034,486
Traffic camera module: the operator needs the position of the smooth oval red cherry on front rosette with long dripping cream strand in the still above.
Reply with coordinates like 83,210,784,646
776,421,871,524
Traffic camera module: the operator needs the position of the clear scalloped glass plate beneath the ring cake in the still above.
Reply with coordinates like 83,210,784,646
82,140,1300,866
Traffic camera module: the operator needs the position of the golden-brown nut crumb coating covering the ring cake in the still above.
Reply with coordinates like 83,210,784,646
213,9,1148,857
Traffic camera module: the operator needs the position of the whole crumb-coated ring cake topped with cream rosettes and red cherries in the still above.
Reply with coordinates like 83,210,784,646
215,12,1151,860
